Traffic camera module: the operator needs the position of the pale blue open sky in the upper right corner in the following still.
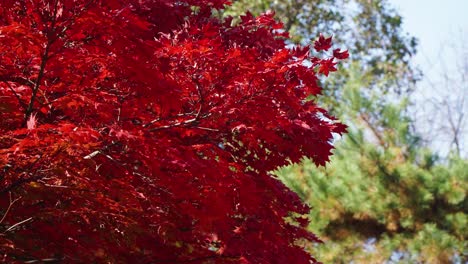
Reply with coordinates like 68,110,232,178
389,0,468,156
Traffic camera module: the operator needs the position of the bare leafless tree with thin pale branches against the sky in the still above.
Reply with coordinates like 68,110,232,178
410,36,468,159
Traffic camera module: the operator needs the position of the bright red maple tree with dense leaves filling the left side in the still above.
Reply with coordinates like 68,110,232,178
0,0,345,263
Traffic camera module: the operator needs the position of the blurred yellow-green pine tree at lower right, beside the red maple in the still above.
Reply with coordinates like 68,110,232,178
278,67,468,263
